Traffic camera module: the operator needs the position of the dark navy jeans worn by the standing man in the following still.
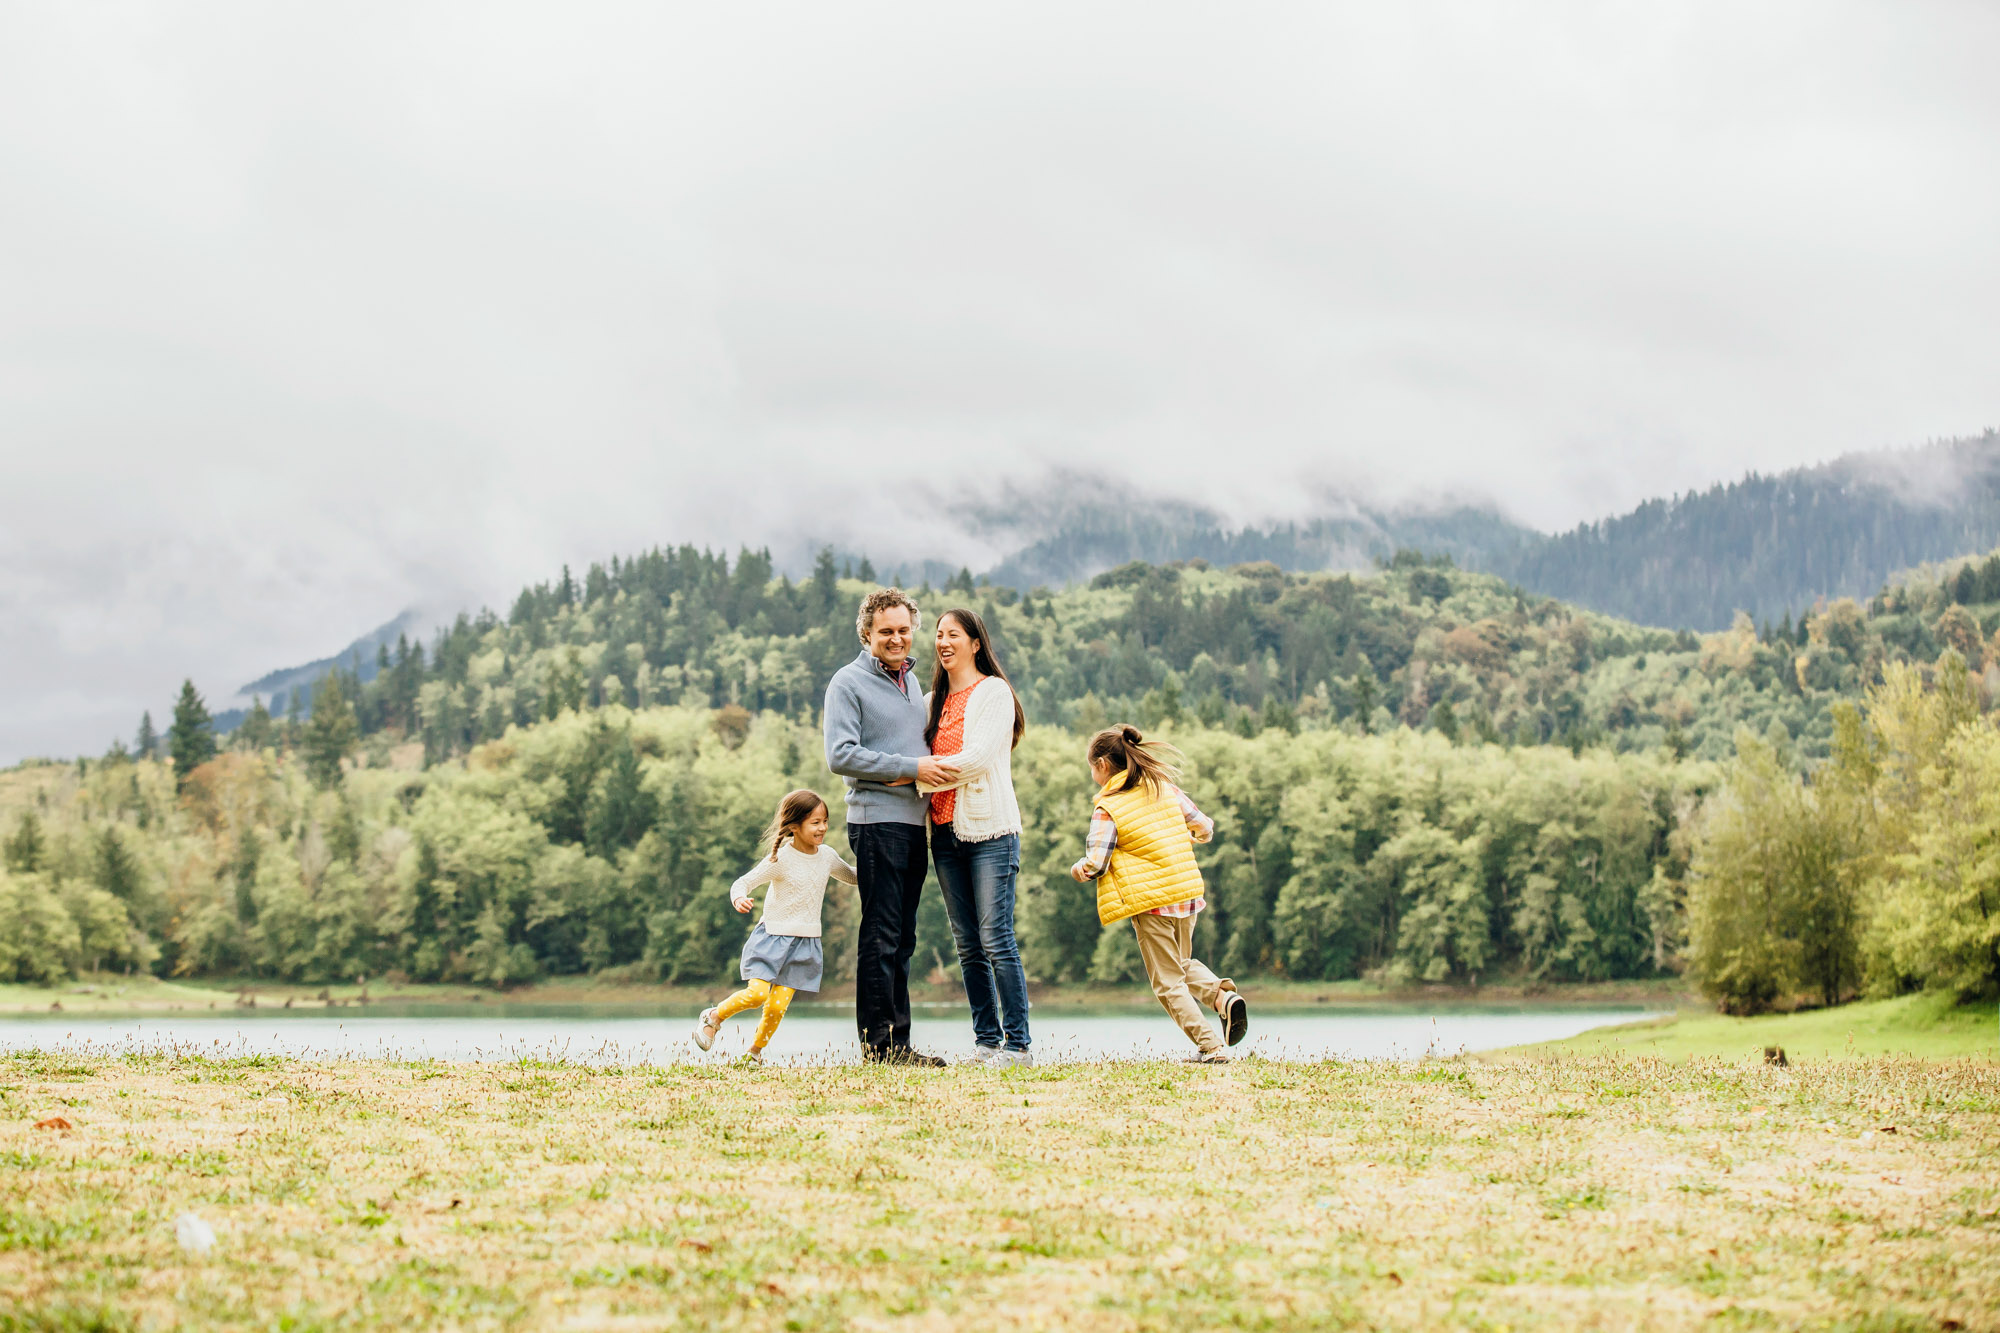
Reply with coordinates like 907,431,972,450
848,823,930,1053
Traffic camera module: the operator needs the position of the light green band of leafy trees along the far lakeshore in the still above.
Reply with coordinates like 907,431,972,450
0,705,1710,985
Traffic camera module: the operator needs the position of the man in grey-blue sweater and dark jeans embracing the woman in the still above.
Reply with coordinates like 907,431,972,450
824,588,956,1065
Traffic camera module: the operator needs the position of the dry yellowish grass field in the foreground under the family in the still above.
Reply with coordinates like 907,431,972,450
0,1055,2000,1329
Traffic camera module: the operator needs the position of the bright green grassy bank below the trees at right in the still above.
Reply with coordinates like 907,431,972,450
1502,995,2000,1061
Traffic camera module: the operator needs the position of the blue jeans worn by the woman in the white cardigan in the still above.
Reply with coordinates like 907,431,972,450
930,825,1028,1051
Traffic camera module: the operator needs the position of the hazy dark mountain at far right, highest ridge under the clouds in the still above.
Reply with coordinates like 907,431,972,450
1472,430,2000,628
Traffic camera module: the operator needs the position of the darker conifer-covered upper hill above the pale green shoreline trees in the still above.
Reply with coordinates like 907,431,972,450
215,528,2000,763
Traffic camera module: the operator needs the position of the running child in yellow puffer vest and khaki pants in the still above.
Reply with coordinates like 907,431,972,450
1070,727,1250,1065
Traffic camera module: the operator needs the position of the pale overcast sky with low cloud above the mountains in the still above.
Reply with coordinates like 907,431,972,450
0,0,2000,763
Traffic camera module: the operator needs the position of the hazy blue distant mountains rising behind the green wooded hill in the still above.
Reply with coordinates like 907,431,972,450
218,430,2000,712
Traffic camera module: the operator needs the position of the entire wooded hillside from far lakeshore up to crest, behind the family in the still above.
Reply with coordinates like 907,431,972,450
0,548,2000,1003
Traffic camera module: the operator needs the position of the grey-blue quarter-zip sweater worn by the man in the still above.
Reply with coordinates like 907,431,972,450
824,648,930,825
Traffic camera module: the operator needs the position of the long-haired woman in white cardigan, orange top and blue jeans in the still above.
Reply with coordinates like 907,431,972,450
918,610,1034,1069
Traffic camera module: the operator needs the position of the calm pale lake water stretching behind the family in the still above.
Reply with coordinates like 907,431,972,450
0,1001,1650,1065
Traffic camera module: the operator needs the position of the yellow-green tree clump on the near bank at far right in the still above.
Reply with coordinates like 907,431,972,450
1688,650,2000,1000
